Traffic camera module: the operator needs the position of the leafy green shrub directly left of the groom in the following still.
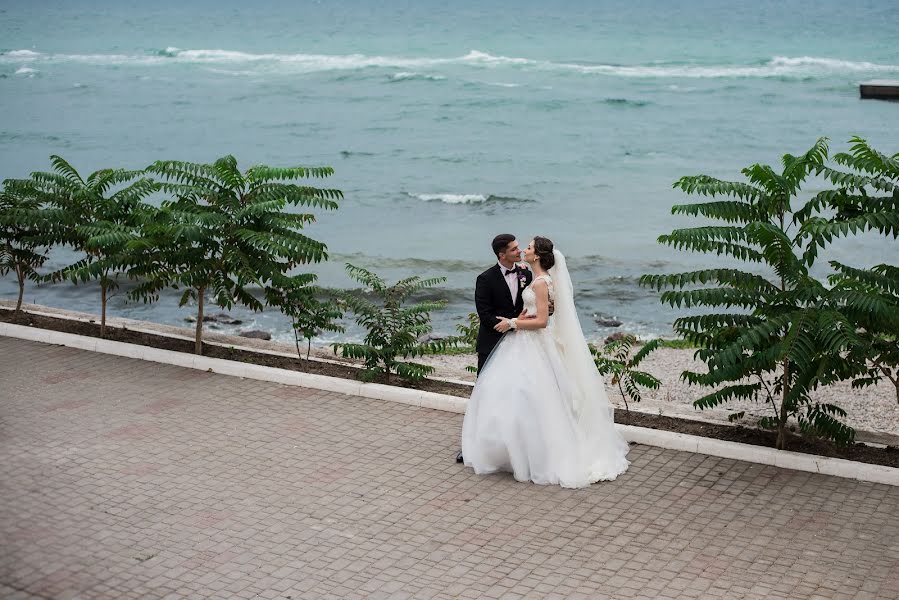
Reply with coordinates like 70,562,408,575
333,263,462,381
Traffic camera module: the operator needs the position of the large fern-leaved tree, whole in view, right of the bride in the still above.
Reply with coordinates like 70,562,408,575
641,138,856,449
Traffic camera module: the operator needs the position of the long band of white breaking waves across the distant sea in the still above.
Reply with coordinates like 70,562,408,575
0,47,899,79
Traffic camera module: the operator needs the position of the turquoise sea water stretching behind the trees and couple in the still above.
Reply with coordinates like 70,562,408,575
0,0,899,336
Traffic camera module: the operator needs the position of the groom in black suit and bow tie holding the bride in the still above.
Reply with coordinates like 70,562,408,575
456,233,533,463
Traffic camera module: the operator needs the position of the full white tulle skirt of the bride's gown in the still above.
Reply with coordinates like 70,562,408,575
462,329,630,488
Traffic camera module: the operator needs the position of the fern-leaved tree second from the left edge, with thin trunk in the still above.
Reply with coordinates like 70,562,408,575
23,155,158,336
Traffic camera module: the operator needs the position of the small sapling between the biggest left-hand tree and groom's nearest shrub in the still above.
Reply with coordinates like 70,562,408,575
268,274,345,360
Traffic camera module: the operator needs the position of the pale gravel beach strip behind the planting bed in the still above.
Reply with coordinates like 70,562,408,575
7,301,899,444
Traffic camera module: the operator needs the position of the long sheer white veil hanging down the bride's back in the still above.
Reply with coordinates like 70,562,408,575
549,250,615,422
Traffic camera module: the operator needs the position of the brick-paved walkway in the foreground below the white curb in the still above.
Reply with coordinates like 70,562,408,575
0,338,899,600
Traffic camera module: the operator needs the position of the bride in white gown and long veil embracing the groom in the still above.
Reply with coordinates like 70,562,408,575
462,237,629,488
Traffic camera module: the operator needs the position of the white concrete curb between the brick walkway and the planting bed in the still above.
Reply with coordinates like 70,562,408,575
0,323,899,486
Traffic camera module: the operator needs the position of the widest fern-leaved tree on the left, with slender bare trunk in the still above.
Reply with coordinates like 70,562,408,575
141,156,343,354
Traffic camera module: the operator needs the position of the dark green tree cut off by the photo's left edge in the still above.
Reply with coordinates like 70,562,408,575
0,180,52,313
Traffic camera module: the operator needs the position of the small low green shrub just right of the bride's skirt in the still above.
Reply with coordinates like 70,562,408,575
590,335,662,412
